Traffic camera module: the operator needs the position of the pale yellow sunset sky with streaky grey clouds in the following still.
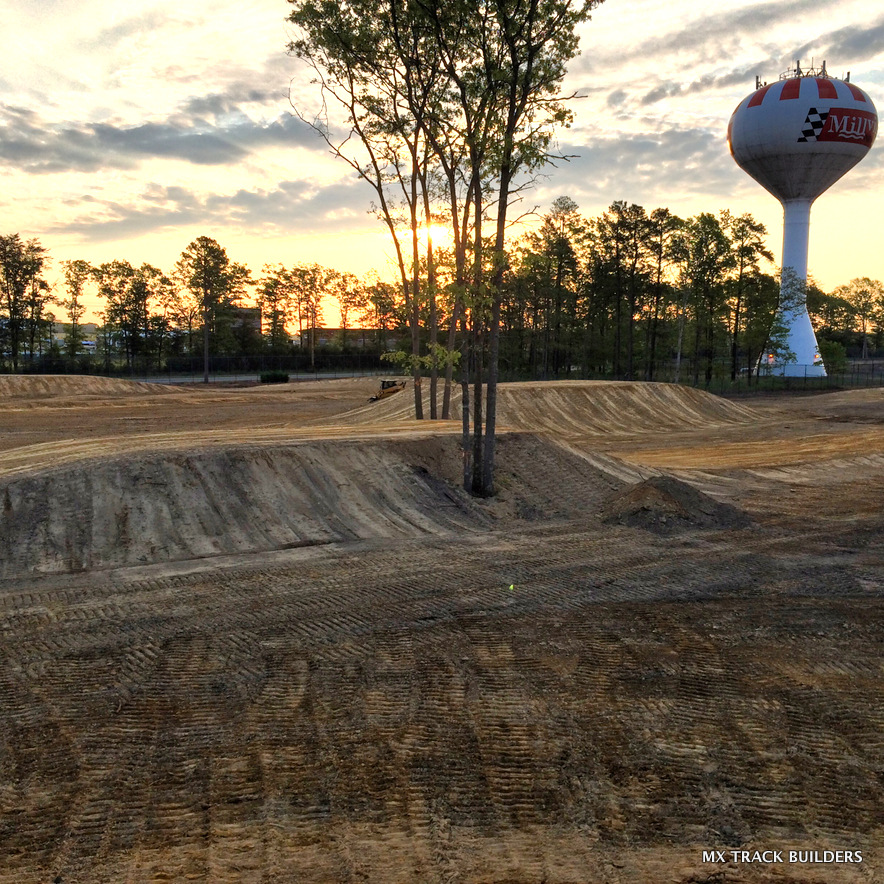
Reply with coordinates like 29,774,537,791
0,0,884,322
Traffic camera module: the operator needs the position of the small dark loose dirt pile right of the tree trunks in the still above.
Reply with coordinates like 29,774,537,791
602,476,749,534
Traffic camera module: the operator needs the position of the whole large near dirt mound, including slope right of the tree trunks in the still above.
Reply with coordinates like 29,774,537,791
0,435,622,579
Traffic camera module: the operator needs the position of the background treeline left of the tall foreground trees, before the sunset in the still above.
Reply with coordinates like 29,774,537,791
0,234,404,372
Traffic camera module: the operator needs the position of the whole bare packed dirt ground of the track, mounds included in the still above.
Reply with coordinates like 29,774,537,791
0,377,884,884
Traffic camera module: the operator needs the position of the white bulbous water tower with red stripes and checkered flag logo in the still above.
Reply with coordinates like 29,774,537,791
727,62,878,377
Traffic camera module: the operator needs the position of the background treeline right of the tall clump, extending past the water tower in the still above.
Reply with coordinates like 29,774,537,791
501,197,884,384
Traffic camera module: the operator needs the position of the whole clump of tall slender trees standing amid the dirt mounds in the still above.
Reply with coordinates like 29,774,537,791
290,0,599,494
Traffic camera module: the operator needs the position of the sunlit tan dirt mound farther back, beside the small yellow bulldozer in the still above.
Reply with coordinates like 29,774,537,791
341,381,758,436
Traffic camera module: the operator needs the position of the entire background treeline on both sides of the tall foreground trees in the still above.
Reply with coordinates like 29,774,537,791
0,209,884,384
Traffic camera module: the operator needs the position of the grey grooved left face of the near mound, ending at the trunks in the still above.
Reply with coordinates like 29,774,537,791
0,442,484,578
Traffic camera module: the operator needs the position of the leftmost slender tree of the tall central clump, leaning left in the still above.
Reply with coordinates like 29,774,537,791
289,0,446,419
